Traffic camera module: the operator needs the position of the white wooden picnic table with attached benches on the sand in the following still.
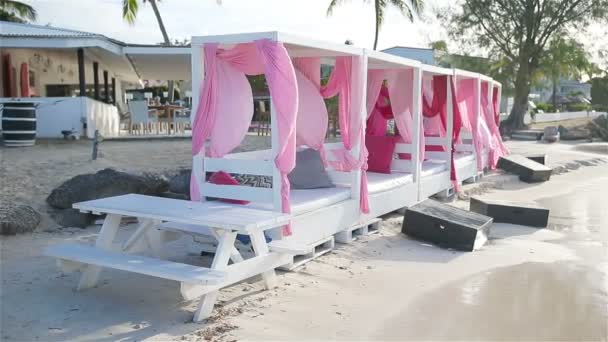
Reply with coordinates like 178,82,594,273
46,194,296,321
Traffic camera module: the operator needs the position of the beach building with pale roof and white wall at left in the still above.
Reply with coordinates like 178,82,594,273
0,22,191,138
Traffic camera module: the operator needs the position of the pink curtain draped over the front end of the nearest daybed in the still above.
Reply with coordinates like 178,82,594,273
190,39,298,235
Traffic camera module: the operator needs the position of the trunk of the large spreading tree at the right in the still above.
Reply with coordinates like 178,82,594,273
504,56,532,130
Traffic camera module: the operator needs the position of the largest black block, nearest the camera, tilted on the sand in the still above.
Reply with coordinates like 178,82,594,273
401,199,492,251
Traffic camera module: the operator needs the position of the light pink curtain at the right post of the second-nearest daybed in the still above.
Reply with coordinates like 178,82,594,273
387,69,425,161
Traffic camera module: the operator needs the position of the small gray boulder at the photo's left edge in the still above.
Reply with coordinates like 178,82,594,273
0,202,41,235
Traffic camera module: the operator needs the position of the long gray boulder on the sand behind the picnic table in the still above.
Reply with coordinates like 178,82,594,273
46,169,168,209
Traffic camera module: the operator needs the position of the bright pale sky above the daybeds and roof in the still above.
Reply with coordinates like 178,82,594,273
22,0,608,68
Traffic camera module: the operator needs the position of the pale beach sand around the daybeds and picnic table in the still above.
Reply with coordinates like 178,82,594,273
0,138,608,341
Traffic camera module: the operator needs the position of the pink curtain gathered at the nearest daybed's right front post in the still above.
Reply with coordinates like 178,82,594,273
321,56,369,213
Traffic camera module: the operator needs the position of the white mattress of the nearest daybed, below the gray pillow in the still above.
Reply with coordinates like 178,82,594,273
247,186,350,215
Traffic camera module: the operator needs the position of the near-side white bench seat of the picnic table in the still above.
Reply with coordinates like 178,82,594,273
46,244,226,285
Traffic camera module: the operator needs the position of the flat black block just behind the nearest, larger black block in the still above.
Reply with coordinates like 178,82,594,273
470,197,549,227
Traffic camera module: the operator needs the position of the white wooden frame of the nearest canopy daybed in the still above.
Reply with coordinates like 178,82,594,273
192,32,366,247
